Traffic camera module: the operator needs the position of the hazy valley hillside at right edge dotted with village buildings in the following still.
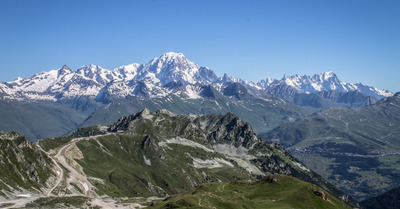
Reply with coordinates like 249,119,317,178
263,93,400,199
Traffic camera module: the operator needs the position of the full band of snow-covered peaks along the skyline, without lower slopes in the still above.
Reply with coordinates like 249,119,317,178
0,52,392,101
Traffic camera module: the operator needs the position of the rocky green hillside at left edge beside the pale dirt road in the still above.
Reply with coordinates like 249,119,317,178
0,132,56,199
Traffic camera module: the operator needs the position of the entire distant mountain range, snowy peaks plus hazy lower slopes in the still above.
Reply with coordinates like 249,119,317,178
0,52,391,141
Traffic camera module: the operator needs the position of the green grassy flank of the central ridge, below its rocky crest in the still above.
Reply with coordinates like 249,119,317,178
77,135,254,197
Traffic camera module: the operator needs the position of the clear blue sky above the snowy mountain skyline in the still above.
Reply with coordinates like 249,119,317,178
0,0,400,92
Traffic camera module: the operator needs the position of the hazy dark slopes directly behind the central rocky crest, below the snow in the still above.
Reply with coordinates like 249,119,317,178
82,88,315,137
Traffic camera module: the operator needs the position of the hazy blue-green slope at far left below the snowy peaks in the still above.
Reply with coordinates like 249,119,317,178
0,97,100,141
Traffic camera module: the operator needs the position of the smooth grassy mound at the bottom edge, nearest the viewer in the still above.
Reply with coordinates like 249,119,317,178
154,175,350,209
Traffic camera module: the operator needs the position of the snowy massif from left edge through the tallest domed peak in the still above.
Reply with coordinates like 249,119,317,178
0,52,217,100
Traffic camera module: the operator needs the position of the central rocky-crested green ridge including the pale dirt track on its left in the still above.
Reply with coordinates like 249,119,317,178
0,109,356,207
